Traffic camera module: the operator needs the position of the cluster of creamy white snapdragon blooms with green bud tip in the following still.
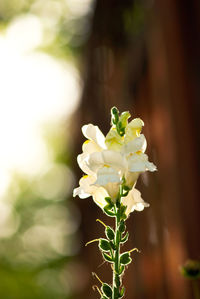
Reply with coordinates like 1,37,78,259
73,107,156,217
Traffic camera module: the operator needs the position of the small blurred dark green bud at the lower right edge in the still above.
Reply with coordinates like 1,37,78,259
180,260,200,279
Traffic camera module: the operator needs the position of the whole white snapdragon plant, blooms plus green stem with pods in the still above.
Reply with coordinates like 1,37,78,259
73,107,156,299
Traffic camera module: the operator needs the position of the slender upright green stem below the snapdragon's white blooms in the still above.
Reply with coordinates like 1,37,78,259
112,206,121,299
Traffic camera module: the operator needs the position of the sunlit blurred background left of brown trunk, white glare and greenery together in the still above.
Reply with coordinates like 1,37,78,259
0,0,92,299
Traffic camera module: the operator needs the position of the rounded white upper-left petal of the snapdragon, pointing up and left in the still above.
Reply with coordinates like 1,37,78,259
82,124,105,149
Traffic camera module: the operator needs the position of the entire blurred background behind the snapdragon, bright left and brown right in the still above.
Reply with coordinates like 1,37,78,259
0,0,200,299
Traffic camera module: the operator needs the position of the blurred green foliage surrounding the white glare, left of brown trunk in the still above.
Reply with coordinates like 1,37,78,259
0,0,91,299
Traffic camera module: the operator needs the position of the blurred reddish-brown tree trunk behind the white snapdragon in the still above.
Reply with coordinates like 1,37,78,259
74,0,200,299
